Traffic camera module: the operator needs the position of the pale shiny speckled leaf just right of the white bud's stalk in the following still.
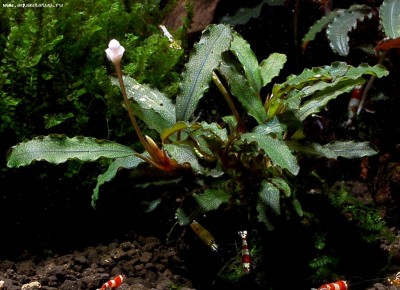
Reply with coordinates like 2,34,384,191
111,76,176,133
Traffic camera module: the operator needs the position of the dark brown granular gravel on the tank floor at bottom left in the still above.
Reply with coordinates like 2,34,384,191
0,237,192,290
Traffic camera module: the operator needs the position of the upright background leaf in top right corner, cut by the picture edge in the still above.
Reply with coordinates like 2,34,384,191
379,0,400,39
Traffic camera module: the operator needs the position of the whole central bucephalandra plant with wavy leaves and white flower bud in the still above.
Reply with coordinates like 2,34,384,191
7,24,388,229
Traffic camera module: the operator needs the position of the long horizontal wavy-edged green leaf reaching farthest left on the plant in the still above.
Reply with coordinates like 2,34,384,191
7,135,136,167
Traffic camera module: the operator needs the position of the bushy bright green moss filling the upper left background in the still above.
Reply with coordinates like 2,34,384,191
0,0,183,140
